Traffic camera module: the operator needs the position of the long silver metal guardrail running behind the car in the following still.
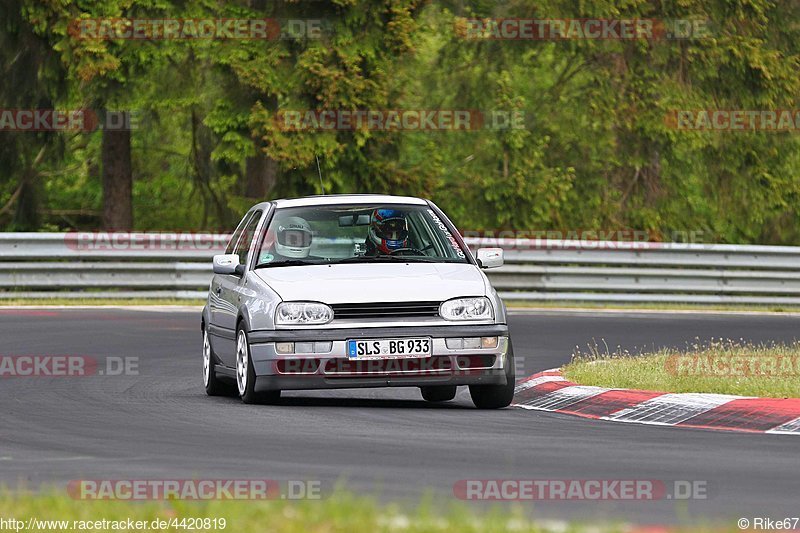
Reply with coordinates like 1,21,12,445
0,233,800,304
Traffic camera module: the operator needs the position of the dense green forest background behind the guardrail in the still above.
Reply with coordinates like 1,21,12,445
0,0,800,244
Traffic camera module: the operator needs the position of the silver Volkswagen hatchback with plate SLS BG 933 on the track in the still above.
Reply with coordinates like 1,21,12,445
202,195,514,409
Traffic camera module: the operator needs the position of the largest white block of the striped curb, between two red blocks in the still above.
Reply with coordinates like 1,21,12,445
601,393,742,426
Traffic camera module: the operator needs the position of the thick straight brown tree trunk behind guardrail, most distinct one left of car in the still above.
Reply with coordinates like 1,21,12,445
102,113,133,230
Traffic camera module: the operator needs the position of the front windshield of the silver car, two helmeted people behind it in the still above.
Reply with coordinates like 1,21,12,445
256,204,468,268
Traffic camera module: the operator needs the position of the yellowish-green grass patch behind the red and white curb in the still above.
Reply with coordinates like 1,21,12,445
563,340,800,398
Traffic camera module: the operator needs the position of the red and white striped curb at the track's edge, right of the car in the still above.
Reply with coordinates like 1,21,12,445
513,369,800,435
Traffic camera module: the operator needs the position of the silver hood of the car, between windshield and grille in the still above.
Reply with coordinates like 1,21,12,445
254,263,486,304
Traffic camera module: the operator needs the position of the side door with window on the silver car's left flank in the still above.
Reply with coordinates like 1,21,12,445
214,209,264,366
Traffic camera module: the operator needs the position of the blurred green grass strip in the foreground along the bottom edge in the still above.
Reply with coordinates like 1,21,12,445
0,491,644,533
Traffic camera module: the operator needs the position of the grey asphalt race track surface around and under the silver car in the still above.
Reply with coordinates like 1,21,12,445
0,309,800,524
